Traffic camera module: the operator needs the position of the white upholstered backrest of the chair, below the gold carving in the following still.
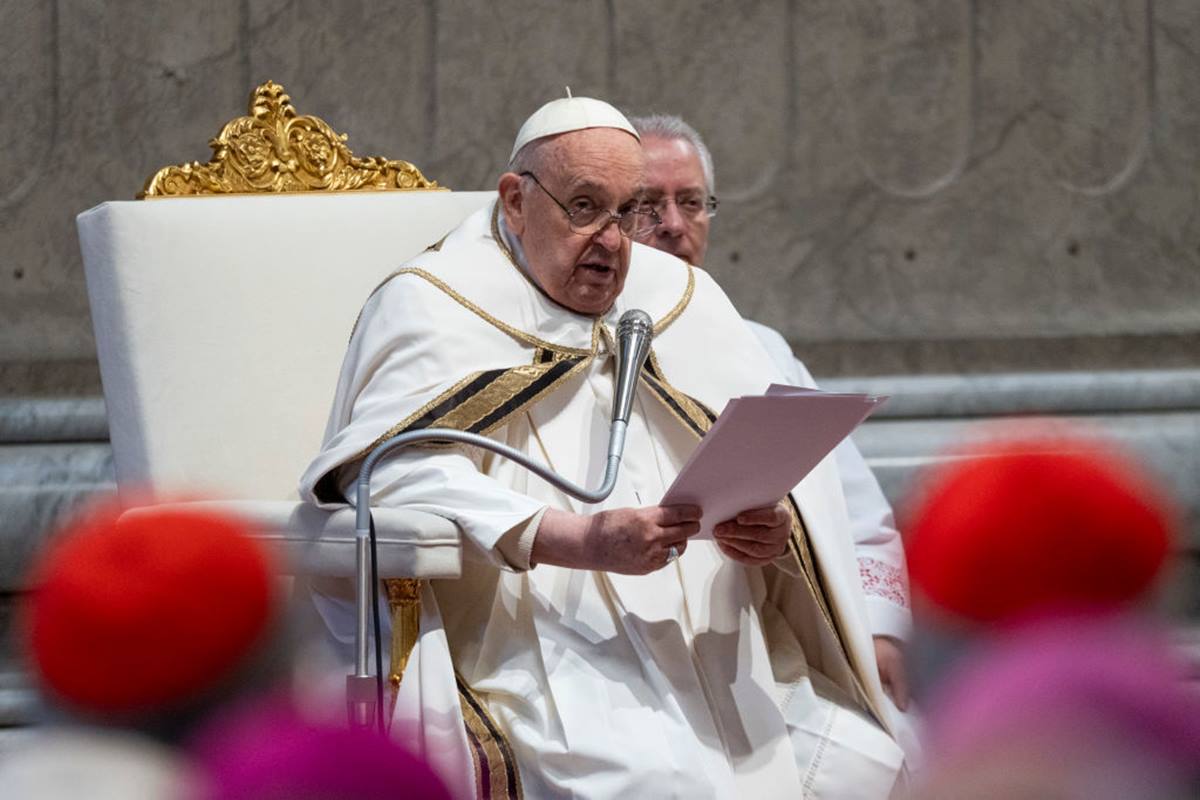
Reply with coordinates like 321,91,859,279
78,191,496,500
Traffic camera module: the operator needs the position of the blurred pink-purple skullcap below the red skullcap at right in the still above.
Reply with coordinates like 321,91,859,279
926,618,1200,778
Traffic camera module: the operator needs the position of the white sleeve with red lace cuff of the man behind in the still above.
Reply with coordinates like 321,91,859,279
746,320,912,639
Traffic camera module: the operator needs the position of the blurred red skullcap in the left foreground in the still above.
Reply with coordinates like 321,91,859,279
28,507,274,715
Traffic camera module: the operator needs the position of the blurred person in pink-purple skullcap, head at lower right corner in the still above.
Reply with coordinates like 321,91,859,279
912,618,1200,800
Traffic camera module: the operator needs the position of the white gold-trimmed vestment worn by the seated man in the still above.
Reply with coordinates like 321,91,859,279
301,203,901,799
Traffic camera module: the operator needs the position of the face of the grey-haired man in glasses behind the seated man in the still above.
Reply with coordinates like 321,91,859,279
637,137,709,266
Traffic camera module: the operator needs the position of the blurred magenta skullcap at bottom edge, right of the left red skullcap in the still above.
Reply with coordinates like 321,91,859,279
193,703,450,800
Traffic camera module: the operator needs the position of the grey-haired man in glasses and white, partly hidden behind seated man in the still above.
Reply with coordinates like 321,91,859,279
630,114,912,710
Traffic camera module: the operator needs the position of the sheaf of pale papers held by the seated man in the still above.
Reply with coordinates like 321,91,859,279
661,384,887,539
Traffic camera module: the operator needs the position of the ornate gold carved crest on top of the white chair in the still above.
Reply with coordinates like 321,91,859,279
138,80,442,198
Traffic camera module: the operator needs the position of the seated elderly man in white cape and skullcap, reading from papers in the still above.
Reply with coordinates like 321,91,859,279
301,97,904,798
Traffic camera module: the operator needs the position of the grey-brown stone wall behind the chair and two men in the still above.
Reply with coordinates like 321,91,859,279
0,0,1200,393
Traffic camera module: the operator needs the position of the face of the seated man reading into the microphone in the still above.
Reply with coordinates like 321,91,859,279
500,128,643,314
